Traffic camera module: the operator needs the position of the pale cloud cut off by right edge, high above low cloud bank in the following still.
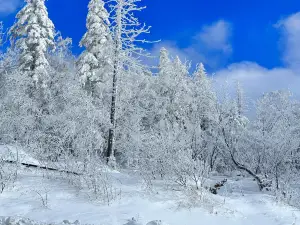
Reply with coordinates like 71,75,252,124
276,12,300,71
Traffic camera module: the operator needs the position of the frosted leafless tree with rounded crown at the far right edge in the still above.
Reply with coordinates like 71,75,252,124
253,91,300,189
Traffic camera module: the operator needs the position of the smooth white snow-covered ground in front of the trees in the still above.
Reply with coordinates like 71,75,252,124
0,149,300,225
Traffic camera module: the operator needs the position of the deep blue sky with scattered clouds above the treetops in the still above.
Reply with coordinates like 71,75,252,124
0,0,300,102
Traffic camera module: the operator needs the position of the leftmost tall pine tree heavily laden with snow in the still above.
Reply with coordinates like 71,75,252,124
9,0,54,89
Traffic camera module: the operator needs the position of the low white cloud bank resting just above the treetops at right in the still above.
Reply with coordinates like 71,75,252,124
215,62,300,102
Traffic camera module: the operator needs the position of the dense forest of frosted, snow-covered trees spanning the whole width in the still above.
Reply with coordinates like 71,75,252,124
0,0,300,224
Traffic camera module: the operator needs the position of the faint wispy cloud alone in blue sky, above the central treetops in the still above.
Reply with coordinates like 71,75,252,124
152,20,232,69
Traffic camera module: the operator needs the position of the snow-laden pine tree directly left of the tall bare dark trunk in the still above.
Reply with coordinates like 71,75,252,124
77,0,112,94
